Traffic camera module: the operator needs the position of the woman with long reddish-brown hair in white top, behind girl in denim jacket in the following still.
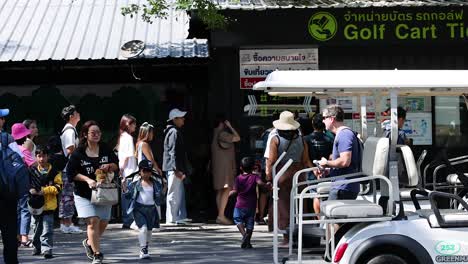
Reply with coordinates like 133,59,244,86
116,114,138,229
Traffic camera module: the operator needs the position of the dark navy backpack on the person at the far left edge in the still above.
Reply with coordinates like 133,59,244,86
0,132,30,197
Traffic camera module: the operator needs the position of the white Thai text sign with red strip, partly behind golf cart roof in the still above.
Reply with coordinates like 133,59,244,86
239,48,318,89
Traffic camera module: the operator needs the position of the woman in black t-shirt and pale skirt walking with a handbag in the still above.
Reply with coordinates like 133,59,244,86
67,120,119,264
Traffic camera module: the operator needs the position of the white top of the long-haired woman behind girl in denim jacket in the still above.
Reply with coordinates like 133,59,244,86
118,132,138,177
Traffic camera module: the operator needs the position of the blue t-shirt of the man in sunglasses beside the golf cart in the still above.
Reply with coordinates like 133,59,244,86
330,128,360,193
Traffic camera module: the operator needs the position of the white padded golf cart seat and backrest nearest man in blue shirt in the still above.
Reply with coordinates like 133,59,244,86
320,137,389,218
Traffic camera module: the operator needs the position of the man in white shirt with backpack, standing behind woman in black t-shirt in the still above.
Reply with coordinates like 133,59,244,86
59,105,82,234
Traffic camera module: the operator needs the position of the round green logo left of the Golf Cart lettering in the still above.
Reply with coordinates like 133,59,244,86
308,12,338,41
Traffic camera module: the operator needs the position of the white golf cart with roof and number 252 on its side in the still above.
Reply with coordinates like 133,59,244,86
254,70,468,264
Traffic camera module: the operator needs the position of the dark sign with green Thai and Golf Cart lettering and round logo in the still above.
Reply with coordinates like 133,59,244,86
307,7,468,42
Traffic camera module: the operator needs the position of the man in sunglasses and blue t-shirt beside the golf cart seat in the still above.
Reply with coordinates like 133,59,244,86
316,105,362,200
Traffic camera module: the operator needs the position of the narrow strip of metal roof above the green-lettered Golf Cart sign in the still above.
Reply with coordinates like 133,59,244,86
212,0,468,10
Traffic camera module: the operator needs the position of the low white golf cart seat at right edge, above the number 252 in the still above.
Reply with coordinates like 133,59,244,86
417,209,468,228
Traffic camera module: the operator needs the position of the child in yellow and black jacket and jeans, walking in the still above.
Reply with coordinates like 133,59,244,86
30,146,62,259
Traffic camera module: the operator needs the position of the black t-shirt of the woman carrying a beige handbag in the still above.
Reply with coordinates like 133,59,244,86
67,143,119,199
